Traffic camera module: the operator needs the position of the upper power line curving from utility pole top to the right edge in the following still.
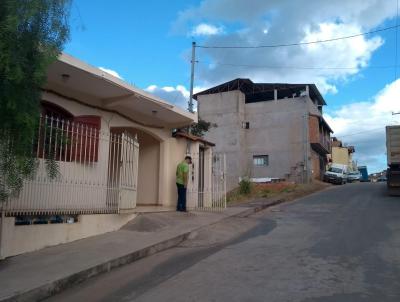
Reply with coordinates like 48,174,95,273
196,24,399,49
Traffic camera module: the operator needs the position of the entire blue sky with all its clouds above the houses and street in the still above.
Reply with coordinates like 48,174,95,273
65,0,400,171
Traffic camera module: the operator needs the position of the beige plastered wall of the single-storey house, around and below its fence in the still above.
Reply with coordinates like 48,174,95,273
0,92,198,258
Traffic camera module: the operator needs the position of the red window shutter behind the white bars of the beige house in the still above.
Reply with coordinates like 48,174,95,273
72,115,101,163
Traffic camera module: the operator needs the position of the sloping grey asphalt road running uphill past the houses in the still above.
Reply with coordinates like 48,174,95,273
49,183,400,302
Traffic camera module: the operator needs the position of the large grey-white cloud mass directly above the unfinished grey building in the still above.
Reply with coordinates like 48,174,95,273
174,0,395,93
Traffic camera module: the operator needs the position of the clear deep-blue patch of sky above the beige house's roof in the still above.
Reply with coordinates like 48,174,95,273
65,0,195,88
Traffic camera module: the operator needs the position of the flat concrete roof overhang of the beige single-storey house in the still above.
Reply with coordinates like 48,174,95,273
44,53,197,129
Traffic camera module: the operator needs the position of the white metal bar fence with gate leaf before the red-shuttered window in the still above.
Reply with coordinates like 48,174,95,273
3,116,139,215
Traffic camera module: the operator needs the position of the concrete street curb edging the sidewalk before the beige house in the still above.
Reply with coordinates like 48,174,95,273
0,207,261,302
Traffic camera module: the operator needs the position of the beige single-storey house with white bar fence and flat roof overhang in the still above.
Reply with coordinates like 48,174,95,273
0,54,222,258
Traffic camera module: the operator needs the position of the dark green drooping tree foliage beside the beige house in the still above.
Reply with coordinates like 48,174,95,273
0,0,71,202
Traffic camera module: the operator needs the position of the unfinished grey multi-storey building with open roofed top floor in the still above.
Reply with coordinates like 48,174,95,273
194,79,332,190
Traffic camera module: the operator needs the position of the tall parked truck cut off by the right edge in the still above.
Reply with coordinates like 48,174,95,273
386,126,400,195
